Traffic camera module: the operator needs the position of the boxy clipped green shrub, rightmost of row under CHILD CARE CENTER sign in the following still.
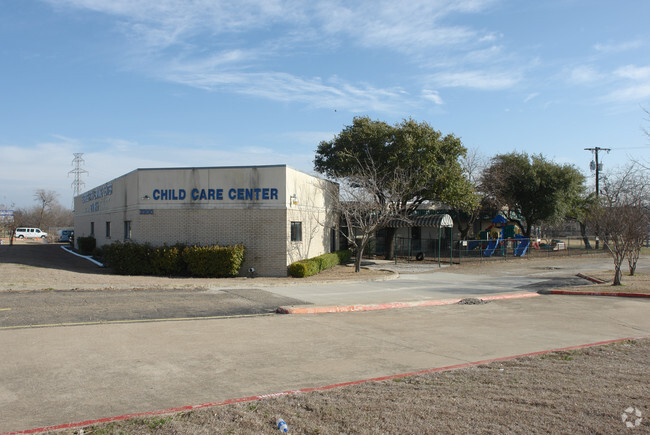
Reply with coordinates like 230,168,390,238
183,245,244,278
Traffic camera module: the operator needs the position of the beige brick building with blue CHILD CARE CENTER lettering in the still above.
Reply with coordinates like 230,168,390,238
74,165,338,276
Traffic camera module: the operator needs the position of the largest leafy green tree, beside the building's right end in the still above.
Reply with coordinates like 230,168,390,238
314,117,475,259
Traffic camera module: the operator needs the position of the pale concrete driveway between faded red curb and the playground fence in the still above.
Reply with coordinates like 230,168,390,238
272,256,616,305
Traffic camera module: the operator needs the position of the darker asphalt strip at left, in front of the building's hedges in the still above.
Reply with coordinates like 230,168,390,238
0,288,307,330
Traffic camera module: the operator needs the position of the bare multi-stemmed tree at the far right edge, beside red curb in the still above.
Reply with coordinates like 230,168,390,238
594,163,650,285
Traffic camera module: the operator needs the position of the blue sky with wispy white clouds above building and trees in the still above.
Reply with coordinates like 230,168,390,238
0,0,650,208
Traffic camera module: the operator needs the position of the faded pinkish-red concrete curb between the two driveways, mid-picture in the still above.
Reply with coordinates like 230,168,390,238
275,293,540,314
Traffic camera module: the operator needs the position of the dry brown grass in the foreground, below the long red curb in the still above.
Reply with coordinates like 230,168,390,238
56,339,650,434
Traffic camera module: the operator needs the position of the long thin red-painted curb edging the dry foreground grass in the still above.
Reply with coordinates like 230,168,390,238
0,335,650,435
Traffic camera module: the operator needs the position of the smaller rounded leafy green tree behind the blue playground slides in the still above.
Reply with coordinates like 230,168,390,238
482,152,584,237
